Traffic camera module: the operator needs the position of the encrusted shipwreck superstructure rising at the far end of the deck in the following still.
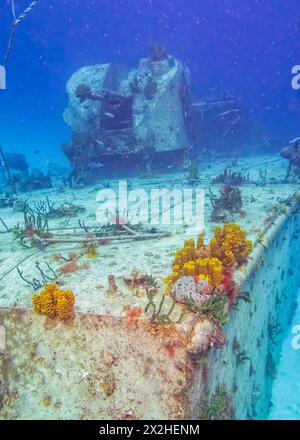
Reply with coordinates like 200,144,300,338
62,45,258,183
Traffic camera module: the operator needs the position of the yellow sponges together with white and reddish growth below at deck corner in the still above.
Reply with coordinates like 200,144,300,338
161,224,252,354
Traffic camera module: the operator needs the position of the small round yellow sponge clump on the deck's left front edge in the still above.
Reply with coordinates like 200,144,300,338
32,284,75,320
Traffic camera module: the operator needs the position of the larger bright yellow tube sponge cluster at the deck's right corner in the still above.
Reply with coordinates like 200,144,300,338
165,223,252,296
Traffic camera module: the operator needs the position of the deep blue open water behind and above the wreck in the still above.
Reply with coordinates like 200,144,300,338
0,0,300,170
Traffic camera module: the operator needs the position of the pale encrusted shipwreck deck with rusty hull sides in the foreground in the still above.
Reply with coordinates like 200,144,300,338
0,156,299,419
